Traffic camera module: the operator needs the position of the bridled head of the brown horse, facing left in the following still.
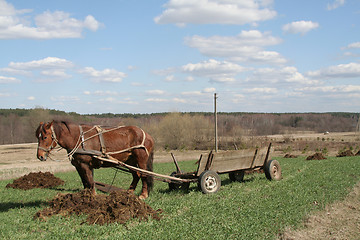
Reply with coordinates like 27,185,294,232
35,121,57,161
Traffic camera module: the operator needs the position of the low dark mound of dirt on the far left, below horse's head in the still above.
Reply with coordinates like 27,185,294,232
6,172,64,190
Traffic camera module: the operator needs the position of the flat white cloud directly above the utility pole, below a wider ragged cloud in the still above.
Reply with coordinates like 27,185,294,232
182,59,247,82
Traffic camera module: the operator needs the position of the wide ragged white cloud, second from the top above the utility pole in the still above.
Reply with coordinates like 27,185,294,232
185,30,286,64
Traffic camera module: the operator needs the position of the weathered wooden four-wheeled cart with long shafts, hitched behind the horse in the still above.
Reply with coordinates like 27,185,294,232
96,143,281,193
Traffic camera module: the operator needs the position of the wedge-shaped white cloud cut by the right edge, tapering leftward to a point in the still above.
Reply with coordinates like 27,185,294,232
307,62,360,79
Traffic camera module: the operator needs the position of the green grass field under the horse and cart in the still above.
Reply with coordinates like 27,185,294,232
0,157,360,239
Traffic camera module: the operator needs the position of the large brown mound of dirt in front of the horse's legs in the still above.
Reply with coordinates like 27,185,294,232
34,189,162,225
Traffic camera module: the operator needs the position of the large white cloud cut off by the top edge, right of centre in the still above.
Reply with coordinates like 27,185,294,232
154,0,277,26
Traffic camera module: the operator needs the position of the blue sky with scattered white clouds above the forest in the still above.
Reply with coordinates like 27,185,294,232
0,0,360,113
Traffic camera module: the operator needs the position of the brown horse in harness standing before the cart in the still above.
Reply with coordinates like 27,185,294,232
36,121,154,199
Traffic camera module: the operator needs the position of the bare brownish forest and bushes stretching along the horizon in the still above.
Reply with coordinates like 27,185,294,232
0,108,359,149
